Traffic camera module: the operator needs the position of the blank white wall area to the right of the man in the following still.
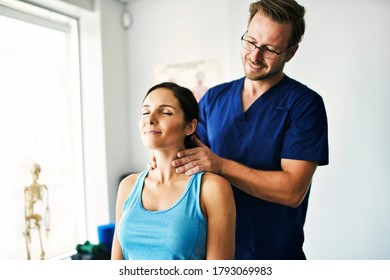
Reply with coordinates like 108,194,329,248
296,0,390,259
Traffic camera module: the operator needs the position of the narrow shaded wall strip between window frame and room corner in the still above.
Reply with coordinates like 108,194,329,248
96,0,130,230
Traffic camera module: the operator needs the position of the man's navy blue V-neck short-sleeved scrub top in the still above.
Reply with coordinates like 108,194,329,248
197,76,328,259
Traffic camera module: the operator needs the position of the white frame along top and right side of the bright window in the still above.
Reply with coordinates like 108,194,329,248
0,0,109,258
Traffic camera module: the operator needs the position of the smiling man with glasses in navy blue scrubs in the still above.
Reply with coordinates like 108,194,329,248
173,0,328,259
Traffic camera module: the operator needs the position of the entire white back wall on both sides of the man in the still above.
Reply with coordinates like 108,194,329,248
125,0,390,259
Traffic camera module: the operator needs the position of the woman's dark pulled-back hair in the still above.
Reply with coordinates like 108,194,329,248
144,82,199,149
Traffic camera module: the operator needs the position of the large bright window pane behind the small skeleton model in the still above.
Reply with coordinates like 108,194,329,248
0,1,86,259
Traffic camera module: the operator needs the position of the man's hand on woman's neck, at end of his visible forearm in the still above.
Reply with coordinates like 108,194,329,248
172,136,222,175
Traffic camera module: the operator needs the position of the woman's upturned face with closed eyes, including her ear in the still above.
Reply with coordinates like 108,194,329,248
139,88,195,151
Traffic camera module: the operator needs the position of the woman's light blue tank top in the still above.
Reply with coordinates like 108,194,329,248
118,170,207,260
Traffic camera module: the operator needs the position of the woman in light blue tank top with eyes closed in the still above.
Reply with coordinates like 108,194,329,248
111,83,236,260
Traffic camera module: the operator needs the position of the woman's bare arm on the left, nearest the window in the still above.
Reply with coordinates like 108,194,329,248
111,174,138,260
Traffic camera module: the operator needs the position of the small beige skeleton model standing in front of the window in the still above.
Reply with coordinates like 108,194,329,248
23,163,49,260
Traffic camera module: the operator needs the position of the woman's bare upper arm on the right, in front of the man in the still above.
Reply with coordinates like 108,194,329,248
201,172,236,260
